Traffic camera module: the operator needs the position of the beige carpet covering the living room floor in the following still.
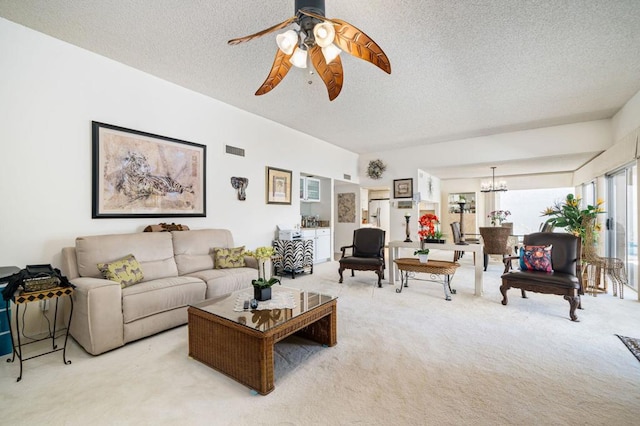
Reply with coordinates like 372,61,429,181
0,252,640,425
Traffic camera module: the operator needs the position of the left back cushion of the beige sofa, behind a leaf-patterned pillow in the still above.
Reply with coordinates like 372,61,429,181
76,231,179,281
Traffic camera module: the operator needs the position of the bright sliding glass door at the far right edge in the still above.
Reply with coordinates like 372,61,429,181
605,164,638,291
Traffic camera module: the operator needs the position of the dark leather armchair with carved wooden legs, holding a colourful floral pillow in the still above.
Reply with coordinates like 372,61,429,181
500,232,584,321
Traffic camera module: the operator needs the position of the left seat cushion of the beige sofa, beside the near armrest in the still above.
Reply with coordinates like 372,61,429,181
122,277,206,324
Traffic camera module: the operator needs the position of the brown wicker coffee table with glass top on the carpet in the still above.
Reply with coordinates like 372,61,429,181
188,285,338,395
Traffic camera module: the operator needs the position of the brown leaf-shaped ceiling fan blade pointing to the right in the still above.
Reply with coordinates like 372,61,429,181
332,19,391,74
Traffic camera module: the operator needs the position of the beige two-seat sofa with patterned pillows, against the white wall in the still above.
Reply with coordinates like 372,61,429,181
61,229,258,355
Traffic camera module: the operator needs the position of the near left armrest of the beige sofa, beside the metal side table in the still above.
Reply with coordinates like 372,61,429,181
70,277,124,355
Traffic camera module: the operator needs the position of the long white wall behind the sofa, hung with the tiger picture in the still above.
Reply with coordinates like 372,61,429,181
0,19,358,266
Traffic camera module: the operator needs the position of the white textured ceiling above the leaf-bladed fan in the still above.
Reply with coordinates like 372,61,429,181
0,0,640,175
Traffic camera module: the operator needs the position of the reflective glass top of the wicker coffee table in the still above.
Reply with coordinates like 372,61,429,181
190,285,337,331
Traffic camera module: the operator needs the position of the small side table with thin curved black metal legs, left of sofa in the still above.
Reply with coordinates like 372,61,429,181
6,287,73,382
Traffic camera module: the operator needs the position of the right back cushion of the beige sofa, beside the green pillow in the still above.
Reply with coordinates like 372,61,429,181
172,229,234,275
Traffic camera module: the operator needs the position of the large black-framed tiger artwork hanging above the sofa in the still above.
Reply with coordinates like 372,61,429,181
91,121,207,218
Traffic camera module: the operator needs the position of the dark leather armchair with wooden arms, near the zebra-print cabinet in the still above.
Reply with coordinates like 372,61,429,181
338,228,385,287
